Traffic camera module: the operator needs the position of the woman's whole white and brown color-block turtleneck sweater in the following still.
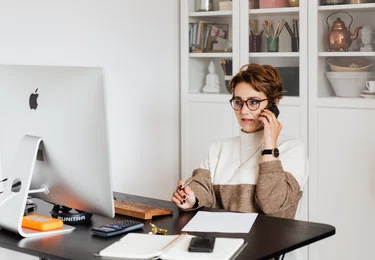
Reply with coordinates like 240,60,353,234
190,130,308,218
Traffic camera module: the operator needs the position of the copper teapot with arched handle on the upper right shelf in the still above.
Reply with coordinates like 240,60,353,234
326,11,362,51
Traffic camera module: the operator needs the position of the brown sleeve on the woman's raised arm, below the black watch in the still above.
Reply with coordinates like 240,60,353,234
255,160,302,218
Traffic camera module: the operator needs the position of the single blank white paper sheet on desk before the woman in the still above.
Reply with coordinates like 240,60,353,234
182,211,258,233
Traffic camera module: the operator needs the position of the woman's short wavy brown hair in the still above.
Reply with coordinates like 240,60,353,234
229,63,283,102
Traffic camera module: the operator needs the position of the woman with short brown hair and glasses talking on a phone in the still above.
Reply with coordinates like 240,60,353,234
172,64,307,218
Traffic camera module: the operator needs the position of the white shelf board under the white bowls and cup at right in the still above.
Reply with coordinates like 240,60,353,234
316,97,375,109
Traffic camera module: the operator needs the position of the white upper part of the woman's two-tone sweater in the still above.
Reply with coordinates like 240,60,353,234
200,130,308,190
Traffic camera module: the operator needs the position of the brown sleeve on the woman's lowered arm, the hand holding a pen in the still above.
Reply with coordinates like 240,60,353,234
189,168,216,210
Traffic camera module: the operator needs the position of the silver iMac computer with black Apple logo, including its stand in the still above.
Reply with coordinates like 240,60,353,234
0,65,114,237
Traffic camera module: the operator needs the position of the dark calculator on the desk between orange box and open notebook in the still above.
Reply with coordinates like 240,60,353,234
91,219,144,237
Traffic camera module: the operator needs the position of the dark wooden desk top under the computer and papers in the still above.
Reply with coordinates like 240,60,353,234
0,192,335,260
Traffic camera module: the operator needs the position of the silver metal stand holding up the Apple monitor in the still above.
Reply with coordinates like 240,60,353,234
0,135,75,237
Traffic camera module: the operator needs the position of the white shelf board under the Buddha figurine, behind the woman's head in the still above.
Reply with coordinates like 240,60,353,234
188,93,301,106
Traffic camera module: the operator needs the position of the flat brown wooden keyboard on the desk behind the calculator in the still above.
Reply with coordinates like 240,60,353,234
114,200,173,219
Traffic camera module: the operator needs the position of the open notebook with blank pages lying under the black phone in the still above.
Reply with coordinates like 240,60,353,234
98,233,247,260
